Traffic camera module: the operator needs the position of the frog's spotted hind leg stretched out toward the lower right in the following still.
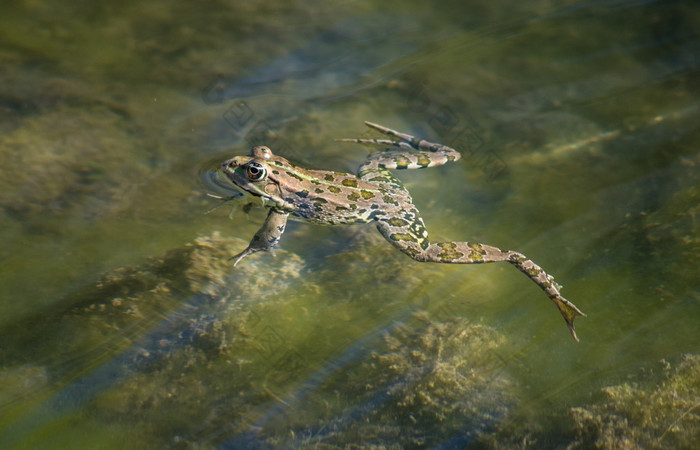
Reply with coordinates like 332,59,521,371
377,216,585,341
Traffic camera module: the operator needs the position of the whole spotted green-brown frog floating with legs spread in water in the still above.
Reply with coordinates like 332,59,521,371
221,122,585,341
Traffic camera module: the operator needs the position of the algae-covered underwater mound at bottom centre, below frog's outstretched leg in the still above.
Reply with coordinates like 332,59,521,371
262,311,515,448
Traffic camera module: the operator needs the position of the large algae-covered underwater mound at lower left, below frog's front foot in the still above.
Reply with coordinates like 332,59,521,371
0,234,306,445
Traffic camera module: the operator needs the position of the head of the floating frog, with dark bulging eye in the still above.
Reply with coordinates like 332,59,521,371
221,146,291,209
